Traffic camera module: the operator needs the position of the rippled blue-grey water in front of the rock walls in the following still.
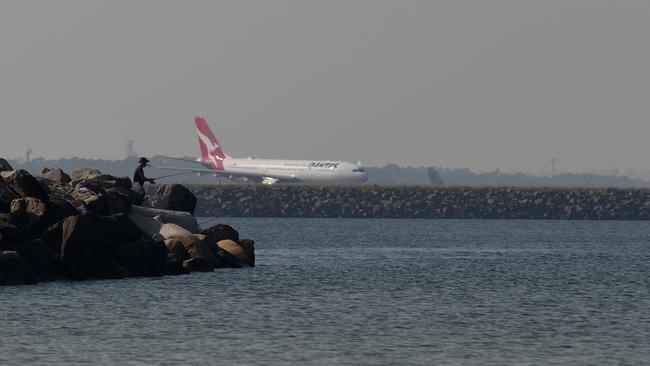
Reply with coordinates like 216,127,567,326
0,219,650,365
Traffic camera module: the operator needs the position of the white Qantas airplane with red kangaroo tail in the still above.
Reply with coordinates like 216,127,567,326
158,116,368,185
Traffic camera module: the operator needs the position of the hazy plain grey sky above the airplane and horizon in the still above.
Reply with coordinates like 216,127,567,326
0,0,650,171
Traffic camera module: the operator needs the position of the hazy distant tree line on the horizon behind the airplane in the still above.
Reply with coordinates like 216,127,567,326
10,156,650,188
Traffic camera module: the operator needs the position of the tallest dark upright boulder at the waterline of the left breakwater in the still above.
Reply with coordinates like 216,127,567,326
61,215,123,279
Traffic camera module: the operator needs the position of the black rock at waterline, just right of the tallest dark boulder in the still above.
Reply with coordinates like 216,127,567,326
115,240,167,276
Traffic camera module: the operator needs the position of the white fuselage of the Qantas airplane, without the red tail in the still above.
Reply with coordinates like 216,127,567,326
206,157,368,184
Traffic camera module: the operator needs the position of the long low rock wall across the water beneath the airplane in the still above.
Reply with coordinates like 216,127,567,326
190,185,650,220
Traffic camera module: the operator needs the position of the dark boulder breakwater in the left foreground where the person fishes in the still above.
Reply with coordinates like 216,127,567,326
0,159,255,285
